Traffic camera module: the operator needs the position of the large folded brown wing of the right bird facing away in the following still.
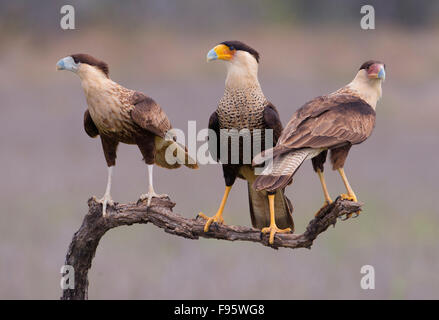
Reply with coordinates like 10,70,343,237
275,95,375,154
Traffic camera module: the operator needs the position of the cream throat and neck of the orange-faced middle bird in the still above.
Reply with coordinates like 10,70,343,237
226,51,260,89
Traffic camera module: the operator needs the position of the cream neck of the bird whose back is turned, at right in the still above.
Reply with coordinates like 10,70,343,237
346,69,382,110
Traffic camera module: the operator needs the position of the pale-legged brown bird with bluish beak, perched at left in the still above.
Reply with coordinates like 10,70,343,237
56,54,198,216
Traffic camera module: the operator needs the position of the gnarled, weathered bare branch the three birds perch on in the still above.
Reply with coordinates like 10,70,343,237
61,197,361,300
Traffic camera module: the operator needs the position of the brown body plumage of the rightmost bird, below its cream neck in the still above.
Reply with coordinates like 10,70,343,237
254,90,375,191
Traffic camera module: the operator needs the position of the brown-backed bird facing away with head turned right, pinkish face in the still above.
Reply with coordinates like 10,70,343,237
253,61,386,218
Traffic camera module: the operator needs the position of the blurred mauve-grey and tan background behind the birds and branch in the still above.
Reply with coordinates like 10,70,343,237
0,0,439,299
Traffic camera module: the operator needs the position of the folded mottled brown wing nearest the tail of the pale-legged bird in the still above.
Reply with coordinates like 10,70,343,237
130,92,171,138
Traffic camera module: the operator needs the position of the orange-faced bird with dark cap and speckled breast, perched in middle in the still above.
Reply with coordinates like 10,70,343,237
199,41,294,243
